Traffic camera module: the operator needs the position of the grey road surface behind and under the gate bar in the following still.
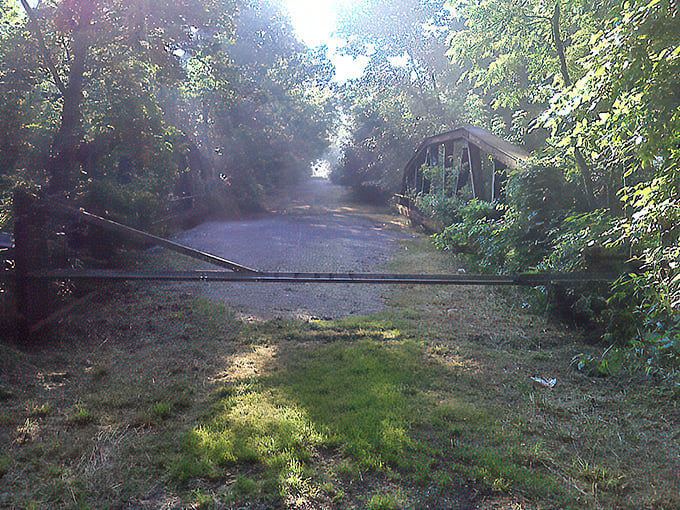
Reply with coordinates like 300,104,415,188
172,178,414,319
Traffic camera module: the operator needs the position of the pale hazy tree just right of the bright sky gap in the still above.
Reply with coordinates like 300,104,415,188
334,0,460,192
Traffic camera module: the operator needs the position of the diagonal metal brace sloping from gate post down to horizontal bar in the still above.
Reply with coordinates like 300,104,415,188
45,201,257,274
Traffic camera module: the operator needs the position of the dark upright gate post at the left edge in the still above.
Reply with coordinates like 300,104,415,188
13,188,48,342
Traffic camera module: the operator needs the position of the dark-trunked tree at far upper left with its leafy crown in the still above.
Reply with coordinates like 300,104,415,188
14,0,238,196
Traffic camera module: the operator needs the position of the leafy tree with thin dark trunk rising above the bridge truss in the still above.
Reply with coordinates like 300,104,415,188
448,0,612,210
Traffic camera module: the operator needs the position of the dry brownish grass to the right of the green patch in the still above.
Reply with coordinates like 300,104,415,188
390,237,680,510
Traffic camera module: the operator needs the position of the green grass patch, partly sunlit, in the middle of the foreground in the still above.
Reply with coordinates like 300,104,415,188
173,318,568,508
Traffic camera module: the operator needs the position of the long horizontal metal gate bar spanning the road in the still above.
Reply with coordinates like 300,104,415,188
29,270,618,287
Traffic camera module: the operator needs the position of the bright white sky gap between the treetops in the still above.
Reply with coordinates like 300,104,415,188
283,0,368,83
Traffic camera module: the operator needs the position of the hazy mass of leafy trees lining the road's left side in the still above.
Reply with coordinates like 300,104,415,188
0,0,332,229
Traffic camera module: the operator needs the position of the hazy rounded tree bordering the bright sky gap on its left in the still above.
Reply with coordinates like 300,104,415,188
190,0,333,195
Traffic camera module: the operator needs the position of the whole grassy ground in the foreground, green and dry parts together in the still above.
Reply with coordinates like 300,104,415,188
0,241,678,509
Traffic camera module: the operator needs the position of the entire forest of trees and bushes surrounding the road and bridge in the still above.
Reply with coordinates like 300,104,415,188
0,0,680,373
